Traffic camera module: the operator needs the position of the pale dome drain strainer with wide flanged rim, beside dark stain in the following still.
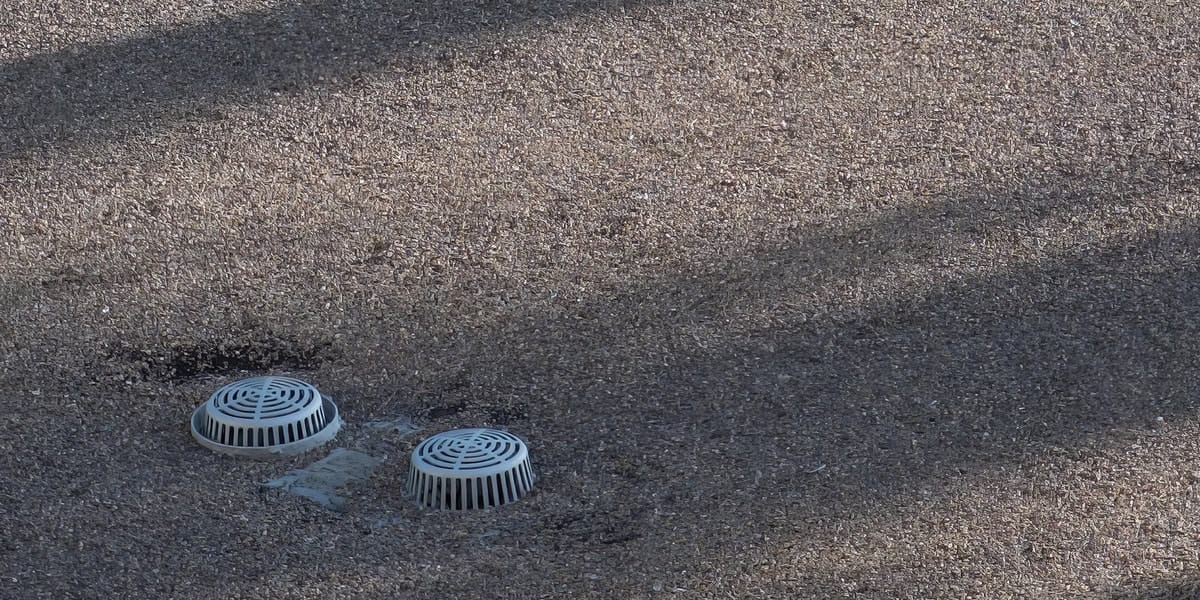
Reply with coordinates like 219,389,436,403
192,377,342,457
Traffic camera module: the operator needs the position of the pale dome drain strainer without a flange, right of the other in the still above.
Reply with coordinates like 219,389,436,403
408,430,535,510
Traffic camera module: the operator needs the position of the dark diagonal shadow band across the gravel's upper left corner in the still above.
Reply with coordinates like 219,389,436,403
0,0,638,158
